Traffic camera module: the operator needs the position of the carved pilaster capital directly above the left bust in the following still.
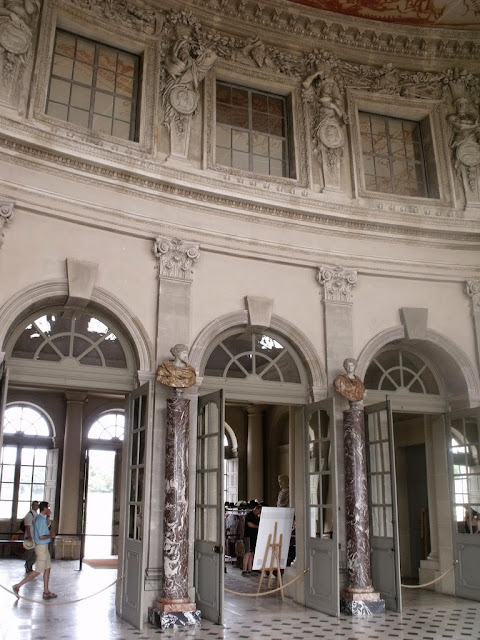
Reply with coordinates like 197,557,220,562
153,237,200,280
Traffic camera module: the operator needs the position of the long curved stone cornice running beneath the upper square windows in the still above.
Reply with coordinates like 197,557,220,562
0,129,480,250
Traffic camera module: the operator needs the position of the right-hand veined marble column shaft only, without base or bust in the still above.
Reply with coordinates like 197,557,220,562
344,409,373,592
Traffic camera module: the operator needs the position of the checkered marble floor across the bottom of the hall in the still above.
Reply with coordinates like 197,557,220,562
0,558,480,640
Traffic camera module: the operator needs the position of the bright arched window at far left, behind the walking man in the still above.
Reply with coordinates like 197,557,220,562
0,403,53,522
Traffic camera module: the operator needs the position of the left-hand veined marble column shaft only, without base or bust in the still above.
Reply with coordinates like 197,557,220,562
163,397,189,602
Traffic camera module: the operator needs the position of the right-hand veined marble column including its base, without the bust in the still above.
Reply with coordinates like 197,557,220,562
340,409,385,616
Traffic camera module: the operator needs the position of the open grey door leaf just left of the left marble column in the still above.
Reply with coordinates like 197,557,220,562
122,383,150,629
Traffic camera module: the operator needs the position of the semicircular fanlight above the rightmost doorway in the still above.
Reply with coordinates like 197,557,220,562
365,348,440,395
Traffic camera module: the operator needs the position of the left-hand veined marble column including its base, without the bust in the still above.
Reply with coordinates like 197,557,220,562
148,394,200,629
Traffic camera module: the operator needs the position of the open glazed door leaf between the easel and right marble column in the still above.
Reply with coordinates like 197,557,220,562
304,398,340,616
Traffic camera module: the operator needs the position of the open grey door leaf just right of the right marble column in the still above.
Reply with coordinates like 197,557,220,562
365,400,402,612
